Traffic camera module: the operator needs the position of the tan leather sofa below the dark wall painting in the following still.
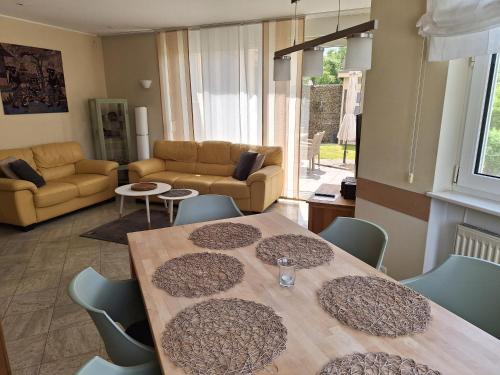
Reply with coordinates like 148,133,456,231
0,142,118,227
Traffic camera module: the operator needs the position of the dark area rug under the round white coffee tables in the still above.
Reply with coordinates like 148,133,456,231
80,209,171,245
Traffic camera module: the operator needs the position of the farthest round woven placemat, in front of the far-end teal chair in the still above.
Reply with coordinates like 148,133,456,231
189,222,262,250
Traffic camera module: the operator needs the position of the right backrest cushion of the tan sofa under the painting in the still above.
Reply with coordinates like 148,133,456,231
31,142,85,181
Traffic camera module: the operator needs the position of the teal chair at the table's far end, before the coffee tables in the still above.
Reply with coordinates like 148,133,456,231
174,194,243,225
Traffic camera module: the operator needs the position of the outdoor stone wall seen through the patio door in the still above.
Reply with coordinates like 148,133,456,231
309,85,342,143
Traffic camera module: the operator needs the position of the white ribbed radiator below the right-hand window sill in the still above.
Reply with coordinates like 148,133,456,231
455,224,500,264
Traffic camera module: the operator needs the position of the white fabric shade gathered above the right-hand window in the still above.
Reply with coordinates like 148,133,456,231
417,0,500,61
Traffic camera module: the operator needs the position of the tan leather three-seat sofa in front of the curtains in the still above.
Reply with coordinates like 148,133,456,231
128,141,283,212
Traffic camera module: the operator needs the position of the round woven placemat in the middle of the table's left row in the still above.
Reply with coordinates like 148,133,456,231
153,253,245,297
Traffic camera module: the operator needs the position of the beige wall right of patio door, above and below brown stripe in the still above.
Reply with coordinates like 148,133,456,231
356,0,448,279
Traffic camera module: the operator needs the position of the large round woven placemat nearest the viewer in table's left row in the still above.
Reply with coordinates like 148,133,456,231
162,298,287,375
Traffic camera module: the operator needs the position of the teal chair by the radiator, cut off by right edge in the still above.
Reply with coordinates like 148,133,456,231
401,255,500,339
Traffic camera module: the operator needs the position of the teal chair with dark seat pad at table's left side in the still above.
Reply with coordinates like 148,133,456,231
68,267,156,366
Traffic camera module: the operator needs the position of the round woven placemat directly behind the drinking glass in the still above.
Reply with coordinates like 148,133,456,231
257,234,333,268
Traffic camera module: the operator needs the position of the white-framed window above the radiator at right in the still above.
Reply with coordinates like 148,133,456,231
457,54,500,197
